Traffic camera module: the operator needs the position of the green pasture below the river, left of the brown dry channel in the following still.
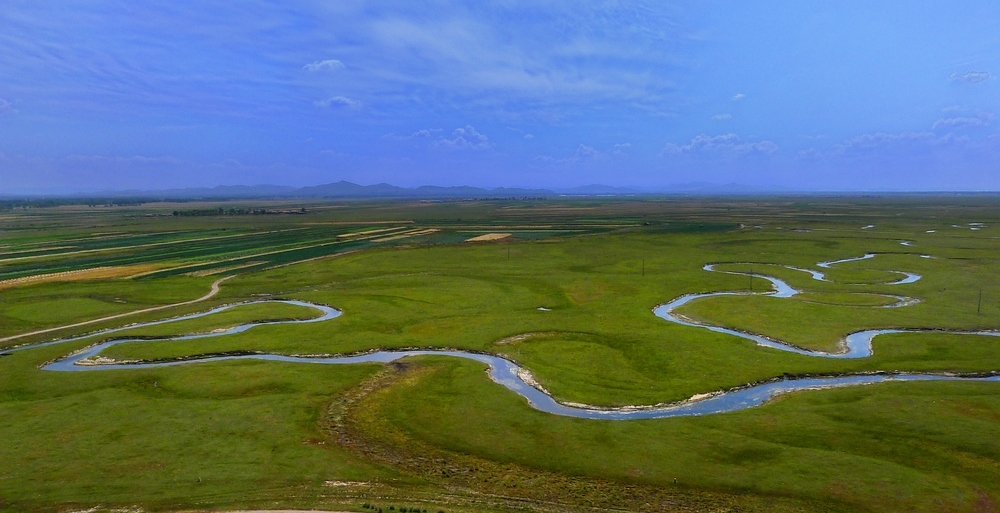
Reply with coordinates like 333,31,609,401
0,347,394,511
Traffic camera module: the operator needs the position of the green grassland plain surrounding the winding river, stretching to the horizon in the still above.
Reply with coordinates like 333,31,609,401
0,197,1000,511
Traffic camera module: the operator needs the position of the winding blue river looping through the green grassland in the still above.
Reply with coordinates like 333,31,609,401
7,253,1000,420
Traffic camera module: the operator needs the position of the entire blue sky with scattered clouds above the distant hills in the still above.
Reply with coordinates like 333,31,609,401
0,0,1000,194
